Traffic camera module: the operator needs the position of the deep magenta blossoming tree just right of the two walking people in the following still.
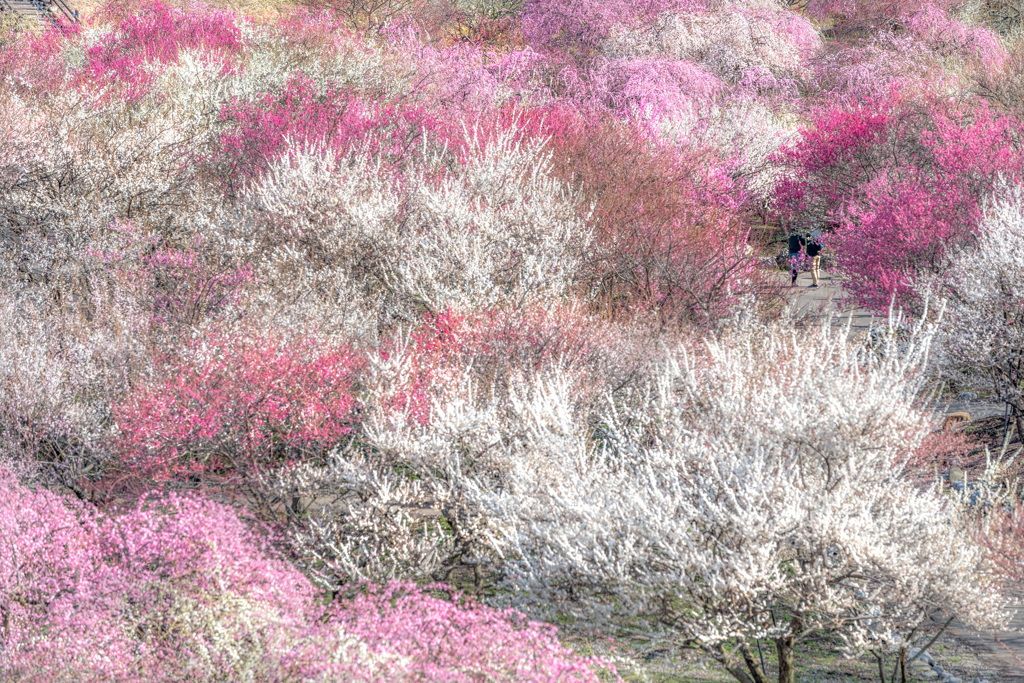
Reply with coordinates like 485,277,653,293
776,95,1024,310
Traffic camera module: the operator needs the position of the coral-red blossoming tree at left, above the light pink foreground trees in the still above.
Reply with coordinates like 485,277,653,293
114,334,359,479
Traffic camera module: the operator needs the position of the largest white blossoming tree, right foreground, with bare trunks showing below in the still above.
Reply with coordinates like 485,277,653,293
354,315,1002,683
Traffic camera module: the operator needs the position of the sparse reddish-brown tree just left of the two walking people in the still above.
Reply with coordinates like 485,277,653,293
547,113,759,325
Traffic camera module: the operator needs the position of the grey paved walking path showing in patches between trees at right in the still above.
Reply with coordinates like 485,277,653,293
780,264,1024,683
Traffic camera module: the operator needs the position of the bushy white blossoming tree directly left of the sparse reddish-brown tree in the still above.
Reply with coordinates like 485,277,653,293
253,130,589,331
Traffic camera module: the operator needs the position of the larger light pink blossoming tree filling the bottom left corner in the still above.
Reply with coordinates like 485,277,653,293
0,471,313,680
